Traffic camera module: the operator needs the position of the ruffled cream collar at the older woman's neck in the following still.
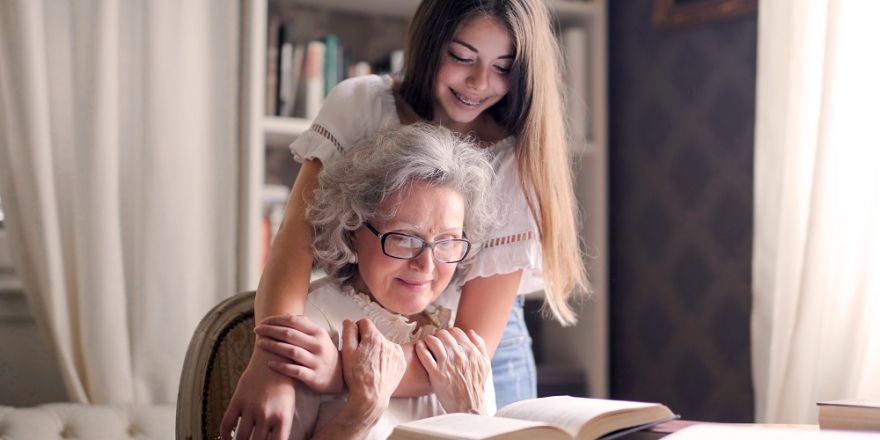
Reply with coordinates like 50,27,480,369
342,286,452,344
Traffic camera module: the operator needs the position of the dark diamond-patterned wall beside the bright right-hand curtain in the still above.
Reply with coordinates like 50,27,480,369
608,0,757,421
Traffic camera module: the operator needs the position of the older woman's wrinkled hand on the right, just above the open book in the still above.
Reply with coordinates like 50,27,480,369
416,327,490,414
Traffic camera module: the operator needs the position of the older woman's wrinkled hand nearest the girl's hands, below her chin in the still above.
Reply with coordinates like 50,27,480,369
342,319,406,414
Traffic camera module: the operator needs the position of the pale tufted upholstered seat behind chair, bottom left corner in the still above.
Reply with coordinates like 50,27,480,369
0,403,174,440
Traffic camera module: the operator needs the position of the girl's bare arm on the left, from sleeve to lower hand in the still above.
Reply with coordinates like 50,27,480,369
220,160,321,439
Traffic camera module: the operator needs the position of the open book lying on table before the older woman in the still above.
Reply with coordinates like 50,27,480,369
388,396,676,440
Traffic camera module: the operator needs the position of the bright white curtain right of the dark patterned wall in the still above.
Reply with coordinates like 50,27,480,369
752,0,880,423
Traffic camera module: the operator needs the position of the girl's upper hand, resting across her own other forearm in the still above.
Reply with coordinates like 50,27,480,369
254,315,345,394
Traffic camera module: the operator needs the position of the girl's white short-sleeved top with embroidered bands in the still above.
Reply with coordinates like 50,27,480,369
290,75,544,300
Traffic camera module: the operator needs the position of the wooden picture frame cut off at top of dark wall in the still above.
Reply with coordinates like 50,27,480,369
652,0,758,30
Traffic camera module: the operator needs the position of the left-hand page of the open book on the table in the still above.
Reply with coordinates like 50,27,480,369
389,413,568,440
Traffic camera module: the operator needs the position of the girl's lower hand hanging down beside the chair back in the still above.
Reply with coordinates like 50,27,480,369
220,350,296,440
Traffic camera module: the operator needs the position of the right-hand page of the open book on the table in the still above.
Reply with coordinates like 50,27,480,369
497,396,671,437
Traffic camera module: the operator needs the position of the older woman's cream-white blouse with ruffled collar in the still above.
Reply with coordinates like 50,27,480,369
290,278,496,439
